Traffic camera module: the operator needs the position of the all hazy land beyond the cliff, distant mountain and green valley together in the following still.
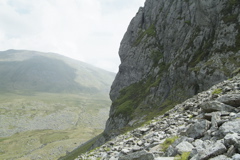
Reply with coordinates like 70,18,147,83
0,50,115,160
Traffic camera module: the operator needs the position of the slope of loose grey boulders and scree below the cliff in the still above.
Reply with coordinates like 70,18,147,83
76,75,240,160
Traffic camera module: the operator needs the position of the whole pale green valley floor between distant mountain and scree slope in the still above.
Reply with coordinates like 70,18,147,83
0,93,110,159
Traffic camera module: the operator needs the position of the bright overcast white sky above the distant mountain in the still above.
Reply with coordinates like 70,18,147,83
0,0,145,72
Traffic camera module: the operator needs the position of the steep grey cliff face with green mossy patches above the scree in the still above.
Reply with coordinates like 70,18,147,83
105,0,240,133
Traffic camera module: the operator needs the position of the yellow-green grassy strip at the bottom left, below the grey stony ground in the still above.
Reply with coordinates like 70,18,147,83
0,128,101,160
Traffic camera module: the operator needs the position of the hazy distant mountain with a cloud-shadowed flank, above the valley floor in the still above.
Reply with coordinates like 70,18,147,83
0,50,115,93
